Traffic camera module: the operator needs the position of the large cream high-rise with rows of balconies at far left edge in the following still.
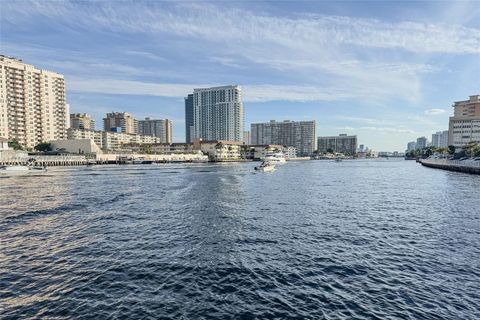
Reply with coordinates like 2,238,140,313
0,55,68,148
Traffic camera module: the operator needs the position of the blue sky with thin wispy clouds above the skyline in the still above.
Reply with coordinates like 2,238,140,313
0,1,480,151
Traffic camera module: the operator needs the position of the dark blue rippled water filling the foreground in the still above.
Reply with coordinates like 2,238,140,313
0,160,480,319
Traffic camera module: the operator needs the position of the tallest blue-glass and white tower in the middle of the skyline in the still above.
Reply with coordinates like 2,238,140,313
189,85,245,142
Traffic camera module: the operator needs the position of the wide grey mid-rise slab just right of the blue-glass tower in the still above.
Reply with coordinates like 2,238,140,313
250,120,317,156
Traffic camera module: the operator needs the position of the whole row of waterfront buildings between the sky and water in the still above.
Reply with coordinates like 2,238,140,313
0,55,480,161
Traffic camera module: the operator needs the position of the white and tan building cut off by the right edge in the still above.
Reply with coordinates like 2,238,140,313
448,95,480,148
